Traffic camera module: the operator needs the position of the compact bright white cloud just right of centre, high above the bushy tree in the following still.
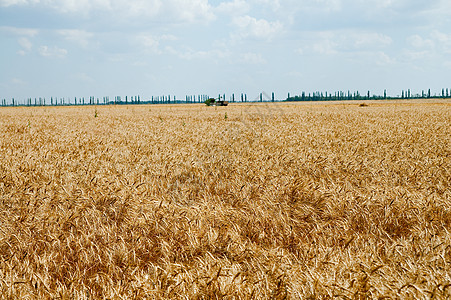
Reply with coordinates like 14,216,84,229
233,16,283,41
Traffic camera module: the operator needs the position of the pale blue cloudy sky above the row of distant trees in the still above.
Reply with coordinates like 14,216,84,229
0,0,451,101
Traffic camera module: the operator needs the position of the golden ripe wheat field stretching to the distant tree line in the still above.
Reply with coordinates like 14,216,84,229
0,100,451,299
